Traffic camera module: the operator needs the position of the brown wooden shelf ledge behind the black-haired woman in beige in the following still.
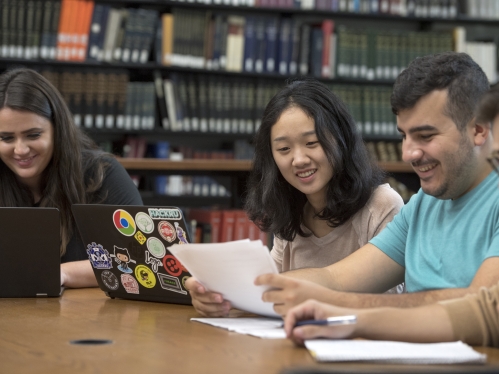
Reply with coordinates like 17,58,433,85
118,158,414,173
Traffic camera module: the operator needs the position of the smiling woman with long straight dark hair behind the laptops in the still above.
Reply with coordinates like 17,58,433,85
0,68,142,287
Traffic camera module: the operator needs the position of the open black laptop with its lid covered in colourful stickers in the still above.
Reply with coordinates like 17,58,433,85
71,204,191,305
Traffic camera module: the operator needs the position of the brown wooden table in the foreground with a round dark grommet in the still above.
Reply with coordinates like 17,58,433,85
0,289,499,374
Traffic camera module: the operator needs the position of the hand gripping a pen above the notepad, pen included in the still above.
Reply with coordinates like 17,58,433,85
284,300,358,345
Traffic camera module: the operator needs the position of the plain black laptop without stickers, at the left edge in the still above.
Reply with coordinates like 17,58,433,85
0,207,63,297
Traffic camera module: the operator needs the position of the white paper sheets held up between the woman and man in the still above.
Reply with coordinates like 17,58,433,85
168,240,279,317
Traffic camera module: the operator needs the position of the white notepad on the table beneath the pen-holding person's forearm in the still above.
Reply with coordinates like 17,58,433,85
305,340,487,364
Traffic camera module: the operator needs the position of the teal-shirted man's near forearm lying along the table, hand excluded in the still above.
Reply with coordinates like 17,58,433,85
321,288,476,308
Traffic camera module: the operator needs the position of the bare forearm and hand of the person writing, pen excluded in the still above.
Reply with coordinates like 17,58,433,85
284,300,454,345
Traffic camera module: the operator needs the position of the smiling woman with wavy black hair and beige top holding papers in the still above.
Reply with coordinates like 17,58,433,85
186,79,403,316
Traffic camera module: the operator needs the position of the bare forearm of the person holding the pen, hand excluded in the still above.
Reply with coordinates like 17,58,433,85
354,305,454,342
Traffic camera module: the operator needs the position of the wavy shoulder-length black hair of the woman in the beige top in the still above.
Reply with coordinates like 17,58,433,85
245,79,384,241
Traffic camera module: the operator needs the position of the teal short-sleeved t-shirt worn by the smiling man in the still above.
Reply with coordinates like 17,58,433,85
370,172,499,292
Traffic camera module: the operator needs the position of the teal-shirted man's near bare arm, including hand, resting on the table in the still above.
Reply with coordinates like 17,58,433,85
257,253,499,315
